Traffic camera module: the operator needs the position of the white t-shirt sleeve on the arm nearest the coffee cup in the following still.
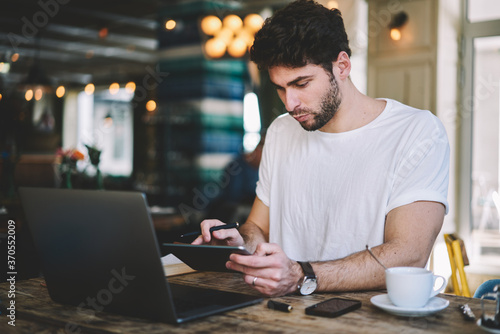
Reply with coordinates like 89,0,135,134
386,113,450,214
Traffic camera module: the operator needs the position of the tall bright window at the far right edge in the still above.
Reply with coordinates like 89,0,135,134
459,0,500,272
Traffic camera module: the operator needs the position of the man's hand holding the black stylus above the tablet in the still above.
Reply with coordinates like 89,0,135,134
191,219,244,246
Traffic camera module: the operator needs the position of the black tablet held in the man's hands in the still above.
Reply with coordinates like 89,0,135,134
163,243,250,272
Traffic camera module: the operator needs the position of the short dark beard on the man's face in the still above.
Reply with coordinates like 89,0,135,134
290,74,342,131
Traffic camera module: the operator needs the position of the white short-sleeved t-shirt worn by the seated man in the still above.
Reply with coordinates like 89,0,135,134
256,99,449,261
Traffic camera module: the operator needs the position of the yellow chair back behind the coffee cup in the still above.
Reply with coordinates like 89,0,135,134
444,234,471,297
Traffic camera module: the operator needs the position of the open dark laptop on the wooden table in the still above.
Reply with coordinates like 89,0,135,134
19,187,263,323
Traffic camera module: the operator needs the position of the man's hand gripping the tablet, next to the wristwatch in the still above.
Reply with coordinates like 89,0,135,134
226,243,303,296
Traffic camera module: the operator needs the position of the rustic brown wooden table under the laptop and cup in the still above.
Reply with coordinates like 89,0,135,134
0,272,492,333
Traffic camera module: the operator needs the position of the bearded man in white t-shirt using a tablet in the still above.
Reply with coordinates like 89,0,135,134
194,0,449,296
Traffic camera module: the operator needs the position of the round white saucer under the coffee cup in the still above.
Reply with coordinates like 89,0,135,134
370,294,450,317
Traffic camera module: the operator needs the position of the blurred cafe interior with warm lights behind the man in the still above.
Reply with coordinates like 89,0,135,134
0,0,500,302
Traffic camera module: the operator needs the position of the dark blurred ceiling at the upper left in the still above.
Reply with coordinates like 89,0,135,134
0,0,287,94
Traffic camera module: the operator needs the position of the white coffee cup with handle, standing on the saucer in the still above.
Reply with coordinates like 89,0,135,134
385,267,446,308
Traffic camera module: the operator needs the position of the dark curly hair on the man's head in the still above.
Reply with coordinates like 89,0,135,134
250,0,351,71
